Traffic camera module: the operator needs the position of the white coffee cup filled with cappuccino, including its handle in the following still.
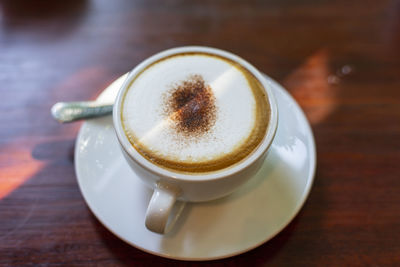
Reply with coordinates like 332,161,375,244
113,46,278,234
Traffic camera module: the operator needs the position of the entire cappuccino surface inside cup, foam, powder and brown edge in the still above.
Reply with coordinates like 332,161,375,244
121,53,270,173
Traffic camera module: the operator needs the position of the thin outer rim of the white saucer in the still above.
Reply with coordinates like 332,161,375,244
74,72,317,262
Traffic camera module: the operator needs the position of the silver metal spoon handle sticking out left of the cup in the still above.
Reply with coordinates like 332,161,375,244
51,101,113,123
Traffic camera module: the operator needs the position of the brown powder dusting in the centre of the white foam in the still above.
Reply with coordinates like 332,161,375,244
164,75,216,137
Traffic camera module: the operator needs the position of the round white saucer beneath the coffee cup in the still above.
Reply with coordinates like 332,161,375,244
75,73,316,260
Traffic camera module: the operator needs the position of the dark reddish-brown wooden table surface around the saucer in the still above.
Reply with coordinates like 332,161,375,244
0,0,400,266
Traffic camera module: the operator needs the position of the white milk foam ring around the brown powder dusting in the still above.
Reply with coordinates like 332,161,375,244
122,54,256,163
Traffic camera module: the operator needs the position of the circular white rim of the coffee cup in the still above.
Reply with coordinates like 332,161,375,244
113,46,278,182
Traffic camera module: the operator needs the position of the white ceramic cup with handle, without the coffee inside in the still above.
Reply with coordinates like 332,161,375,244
113,46,278,234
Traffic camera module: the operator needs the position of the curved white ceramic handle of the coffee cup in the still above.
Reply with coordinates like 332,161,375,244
145,182,184,234
